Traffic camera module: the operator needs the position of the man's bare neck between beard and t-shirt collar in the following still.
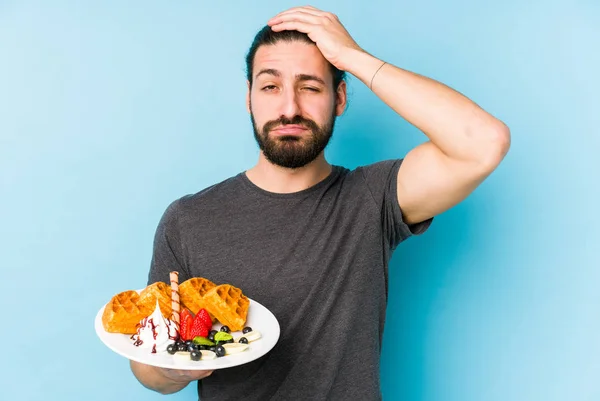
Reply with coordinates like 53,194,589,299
246,153,332,193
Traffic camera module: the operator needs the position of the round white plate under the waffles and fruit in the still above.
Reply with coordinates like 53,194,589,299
94,291,280,370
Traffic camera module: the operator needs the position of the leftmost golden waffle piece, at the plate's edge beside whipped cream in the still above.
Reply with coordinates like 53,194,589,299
102,291,146,334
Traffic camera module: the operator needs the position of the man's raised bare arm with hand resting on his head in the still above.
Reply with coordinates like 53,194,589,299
269,7,510,224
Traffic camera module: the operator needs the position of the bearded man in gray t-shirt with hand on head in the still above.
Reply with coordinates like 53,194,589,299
131,7,510,401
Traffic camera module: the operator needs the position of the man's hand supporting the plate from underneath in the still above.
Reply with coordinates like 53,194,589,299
130,361,212,394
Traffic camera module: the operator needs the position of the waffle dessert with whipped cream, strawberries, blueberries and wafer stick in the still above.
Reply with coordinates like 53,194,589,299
102,272,261,360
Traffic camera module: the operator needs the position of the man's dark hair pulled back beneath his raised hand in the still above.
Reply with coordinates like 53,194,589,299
246,25,346,90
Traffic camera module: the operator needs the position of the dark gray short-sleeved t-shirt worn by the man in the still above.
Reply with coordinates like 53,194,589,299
148,159,432,401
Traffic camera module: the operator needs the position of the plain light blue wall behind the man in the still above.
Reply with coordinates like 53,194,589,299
0,0,600,401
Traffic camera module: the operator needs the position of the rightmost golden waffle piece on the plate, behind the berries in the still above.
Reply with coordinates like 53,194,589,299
203,284,250,331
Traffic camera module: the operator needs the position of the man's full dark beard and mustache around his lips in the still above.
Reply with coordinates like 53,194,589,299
250,108,335,169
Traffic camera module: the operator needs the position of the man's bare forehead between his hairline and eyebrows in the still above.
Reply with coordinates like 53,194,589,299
253,41,330,80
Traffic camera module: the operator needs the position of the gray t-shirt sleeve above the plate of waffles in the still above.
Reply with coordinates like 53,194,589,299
148,201,189,285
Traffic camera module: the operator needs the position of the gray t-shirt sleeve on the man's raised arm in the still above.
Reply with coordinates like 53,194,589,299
358,159,433,249
